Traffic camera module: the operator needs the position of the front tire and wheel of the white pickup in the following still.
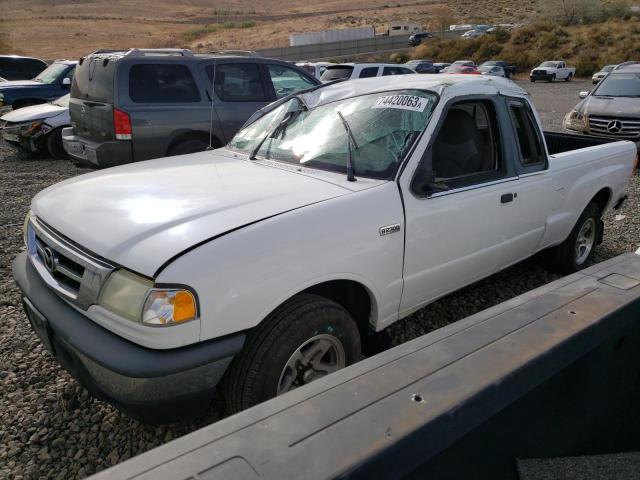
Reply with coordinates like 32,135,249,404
222,294,360,413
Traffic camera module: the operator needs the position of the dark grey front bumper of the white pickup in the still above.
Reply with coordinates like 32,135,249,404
12,252,245,423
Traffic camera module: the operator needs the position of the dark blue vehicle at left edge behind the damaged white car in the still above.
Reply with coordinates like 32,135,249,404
0,60,78,110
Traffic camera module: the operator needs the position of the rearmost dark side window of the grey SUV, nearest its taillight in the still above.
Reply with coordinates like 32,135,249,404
129,63,200,103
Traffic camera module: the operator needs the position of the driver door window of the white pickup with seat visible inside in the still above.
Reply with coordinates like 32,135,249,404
430,101,503,188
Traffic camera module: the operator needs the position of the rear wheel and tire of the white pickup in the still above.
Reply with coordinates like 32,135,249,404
549,202,602,275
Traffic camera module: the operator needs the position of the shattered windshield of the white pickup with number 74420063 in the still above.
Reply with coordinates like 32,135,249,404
227,90,437,179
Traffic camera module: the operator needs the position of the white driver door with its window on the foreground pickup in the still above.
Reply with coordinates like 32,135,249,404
400,97,540,316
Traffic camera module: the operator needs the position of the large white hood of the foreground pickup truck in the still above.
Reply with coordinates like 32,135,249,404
32,150,350,277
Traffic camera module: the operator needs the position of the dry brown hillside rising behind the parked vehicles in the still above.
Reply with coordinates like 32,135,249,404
0,0,539,59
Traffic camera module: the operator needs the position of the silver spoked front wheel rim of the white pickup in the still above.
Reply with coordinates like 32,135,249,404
277,334,346,395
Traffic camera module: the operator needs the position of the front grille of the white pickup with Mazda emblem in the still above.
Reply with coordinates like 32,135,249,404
27,217,114,309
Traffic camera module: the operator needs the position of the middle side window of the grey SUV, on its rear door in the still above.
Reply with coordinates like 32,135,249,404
206,63,267,102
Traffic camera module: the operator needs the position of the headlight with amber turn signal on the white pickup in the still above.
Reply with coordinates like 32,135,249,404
98,270,197,326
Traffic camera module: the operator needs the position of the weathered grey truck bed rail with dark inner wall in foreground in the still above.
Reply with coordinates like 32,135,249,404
92,254,640,480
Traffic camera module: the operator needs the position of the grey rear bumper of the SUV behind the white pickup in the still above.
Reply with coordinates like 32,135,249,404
62,127,133,168
